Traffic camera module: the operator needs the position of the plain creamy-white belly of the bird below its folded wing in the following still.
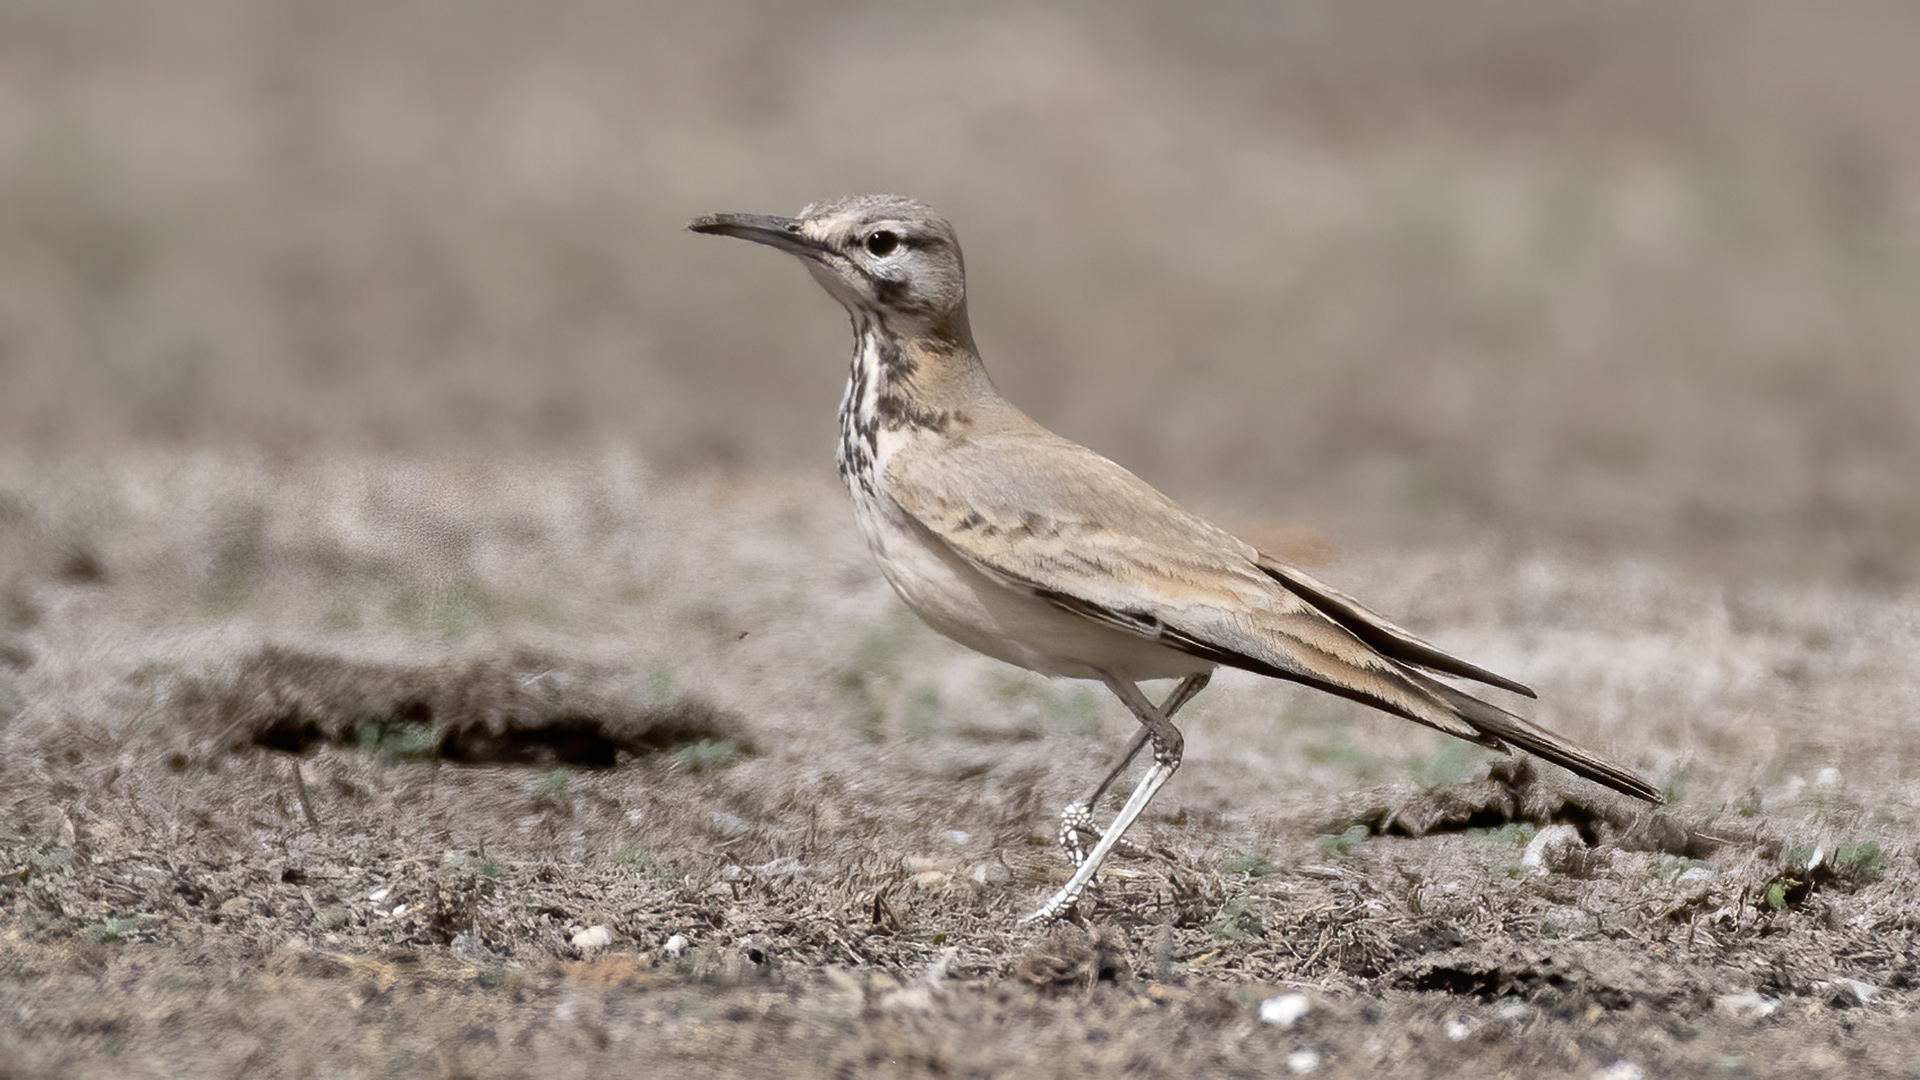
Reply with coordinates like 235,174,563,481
854,494,1213,682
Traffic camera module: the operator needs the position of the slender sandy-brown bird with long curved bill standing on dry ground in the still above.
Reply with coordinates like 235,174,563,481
687,194,1663,924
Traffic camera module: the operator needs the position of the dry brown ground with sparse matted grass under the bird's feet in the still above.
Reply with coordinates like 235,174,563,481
0,454,1920,1076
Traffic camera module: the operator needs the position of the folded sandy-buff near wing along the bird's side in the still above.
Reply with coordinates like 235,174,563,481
887,429,1503,748
